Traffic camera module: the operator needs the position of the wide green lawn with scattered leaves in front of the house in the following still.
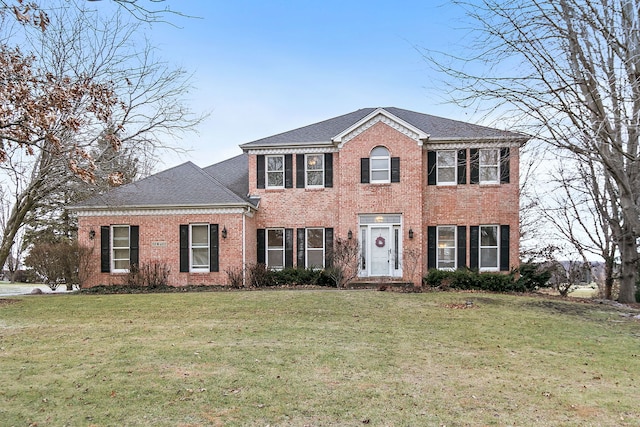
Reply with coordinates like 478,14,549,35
0,290,640,427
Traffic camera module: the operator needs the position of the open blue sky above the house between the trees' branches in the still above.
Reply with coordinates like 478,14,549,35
142,0,473,167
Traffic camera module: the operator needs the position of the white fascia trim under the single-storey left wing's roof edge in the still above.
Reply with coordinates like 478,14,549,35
76,205,253,217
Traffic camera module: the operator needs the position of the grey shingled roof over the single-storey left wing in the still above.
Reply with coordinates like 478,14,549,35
74,160,250,210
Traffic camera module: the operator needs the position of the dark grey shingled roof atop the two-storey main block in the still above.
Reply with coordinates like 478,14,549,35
240,107,527,150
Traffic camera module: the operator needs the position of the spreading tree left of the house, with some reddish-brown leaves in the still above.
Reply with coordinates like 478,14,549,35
0,2,202,265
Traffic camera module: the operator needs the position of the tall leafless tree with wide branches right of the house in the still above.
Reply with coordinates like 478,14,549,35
426,0,640,302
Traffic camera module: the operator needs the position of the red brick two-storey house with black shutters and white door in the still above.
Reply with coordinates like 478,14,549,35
73,108,528,286
